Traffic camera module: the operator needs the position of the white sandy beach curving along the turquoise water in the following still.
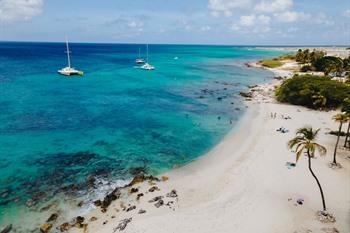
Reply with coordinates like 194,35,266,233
72,61,350,233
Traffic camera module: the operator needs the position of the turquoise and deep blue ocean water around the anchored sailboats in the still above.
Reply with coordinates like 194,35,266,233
0,42,281,230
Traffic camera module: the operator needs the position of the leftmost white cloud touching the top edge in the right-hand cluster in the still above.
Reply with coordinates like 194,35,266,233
208,0,251,16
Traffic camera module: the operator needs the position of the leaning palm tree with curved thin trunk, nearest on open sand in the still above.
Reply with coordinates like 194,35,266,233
288,127,327,211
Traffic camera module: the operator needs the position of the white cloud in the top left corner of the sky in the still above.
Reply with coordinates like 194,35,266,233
0,0,43,23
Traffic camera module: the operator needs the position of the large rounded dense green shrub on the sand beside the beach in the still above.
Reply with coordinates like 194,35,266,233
276,75,350,109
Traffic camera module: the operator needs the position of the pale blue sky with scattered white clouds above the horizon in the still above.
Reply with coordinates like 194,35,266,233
0,0,350,45
